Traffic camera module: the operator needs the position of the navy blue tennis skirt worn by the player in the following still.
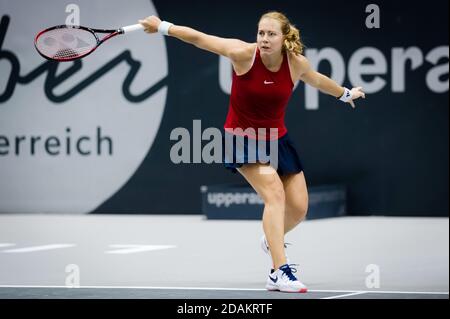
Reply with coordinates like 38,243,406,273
222,132,303,175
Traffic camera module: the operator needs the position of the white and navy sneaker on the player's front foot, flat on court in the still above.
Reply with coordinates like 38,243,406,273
266,264,308,293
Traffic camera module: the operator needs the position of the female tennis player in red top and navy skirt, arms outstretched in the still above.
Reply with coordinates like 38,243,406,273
139,12,365,292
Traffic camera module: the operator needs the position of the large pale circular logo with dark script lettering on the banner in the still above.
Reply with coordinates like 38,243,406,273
0,0,168,213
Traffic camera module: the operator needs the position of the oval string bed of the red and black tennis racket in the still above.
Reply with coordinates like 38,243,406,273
36,27,97,60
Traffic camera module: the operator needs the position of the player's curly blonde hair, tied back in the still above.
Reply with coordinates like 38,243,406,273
259,11,305,55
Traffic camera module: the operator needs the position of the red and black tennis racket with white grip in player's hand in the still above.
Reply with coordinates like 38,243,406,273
34,24,144,62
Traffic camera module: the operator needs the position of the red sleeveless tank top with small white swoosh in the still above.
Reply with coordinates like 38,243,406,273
224,48,294,140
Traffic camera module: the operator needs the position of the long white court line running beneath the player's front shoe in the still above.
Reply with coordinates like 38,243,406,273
0,285,449,295
